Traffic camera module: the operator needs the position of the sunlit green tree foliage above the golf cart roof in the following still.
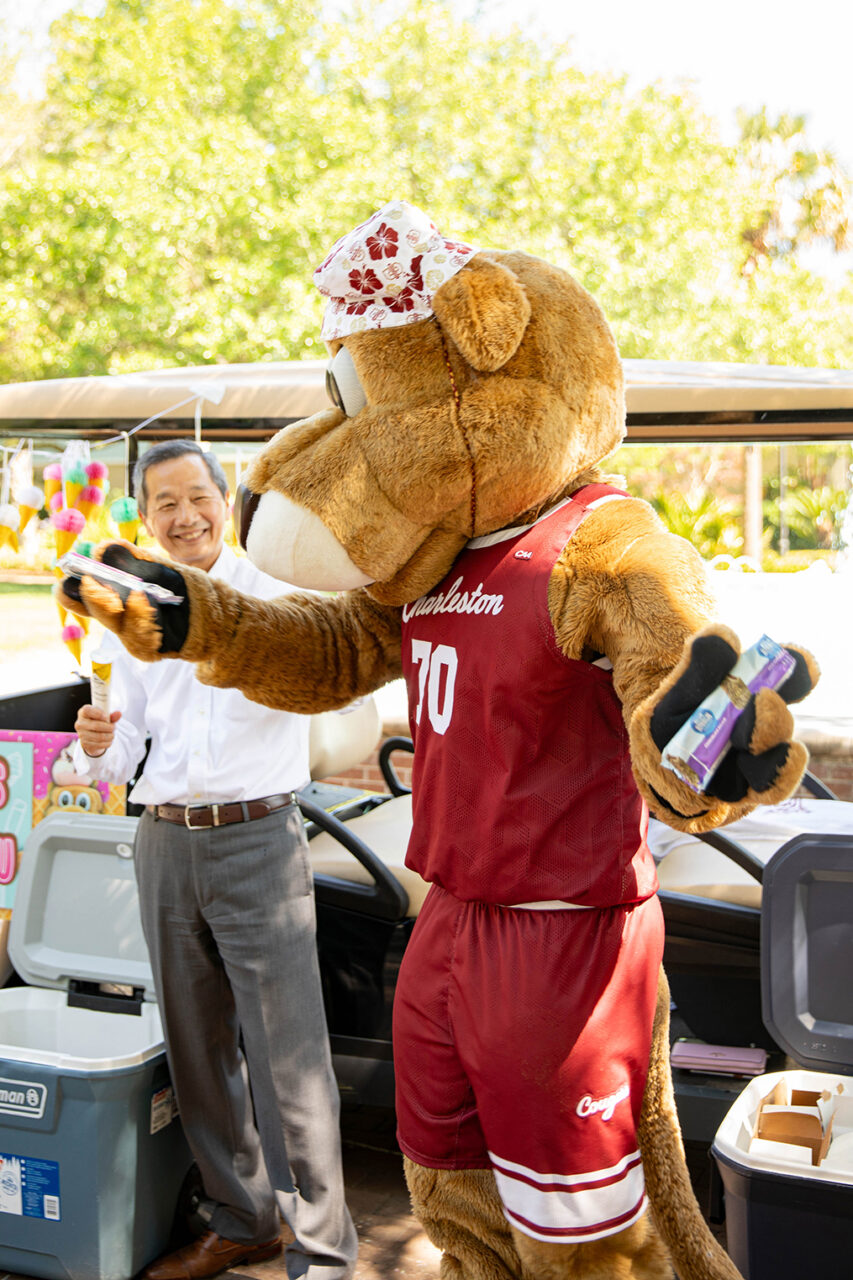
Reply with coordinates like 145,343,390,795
0,0,853,379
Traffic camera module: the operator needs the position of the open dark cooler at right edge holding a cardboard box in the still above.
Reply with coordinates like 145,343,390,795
711,835,853,1280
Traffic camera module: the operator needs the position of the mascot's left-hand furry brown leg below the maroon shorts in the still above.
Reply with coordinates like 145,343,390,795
403,1156,522,1280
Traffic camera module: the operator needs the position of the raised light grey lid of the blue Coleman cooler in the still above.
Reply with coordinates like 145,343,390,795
9,813,156,1001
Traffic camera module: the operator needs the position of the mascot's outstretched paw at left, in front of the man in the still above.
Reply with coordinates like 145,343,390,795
54,541,190,662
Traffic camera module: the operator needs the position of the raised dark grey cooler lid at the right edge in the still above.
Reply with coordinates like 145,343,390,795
761,833,853,1075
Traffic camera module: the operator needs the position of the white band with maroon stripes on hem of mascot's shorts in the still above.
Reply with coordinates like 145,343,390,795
489,1151,647,1244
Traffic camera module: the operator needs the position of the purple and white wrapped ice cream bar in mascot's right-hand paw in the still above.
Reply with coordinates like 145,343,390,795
661,636,795,791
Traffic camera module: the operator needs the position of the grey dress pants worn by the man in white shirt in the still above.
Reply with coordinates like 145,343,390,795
134,806,357,1280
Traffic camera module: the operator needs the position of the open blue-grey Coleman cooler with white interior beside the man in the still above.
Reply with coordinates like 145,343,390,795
0,813,192,1280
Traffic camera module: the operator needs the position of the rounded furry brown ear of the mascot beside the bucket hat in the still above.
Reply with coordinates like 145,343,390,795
433,253,530,374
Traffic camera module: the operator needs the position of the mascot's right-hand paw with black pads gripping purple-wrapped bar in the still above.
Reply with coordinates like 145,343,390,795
637,626,818,829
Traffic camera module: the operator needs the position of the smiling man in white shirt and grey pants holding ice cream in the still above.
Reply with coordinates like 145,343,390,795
68,440,356,1280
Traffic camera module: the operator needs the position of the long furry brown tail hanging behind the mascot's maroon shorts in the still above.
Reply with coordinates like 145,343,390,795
639,969,743,1280
